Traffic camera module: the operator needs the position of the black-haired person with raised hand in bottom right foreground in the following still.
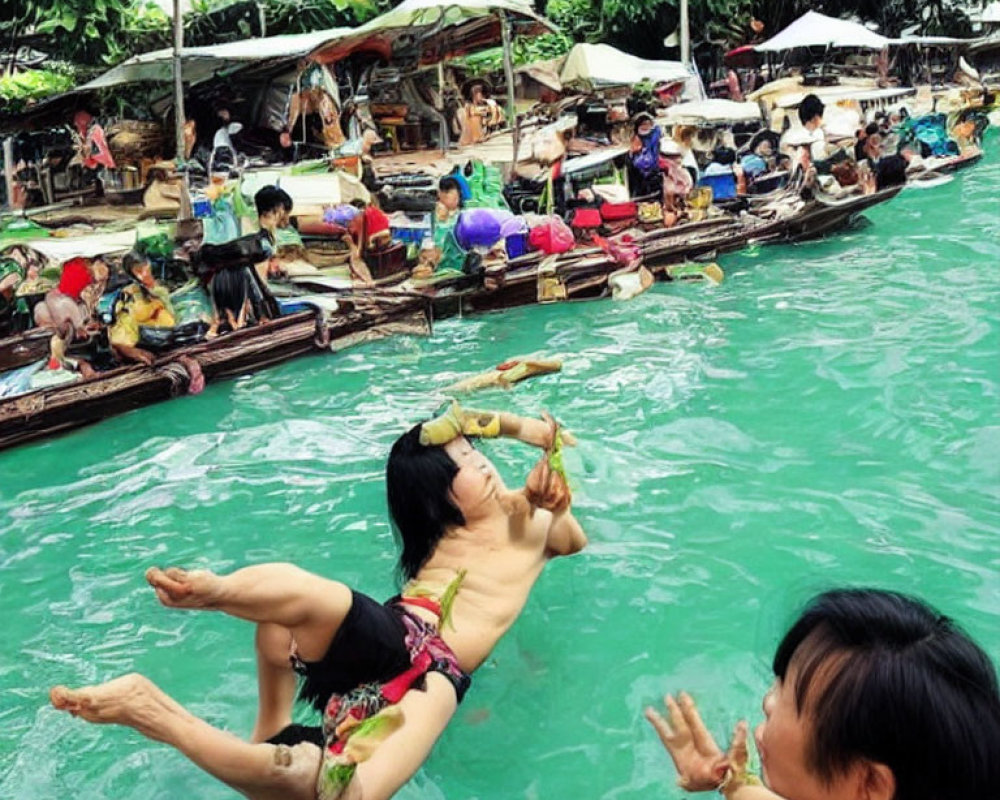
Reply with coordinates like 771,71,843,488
646,589,1000,800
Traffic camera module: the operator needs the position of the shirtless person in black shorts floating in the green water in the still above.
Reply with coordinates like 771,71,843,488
50,407,587,800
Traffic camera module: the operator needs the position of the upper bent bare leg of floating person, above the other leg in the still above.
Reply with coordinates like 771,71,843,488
146,564,353,661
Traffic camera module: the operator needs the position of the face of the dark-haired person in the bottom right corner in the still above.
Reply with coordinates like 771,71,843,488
754,667,861,800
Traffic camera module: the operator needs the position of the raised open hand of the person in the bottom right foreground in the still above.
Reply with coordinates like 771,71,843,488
646,692,732,792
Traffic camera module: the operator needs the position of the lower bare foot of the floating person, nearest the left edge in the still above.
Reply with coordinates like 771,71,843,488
49,674,188,741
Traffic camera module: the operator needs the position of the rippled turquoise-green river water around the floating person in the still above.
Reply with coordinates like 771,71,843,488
0,141,1000,800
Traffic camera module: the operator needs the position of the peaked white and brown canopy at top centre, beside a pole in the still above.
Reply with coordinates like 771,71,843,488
309,0,556,64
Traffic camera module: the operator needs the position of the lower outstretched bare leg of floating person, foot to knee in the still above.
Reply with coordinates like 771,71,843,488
49,674,321,800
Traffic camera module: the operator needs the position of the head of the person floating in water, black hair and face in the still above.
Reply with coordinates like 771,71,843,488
385,425,499,579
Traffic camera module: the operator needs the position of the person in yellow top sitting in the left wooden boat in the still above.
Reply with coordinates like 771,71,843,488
108,250,176,366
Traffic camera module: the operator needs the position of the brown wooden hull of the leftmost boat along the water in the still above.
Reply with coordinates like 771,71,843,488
0,295,430,456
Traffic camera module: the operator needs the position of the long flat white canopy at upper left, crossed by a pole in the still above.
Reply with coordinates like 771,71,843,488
78,28,354,91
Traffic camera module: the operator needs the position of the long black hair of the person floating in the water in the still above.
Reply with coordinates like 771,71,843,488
385,425,465,580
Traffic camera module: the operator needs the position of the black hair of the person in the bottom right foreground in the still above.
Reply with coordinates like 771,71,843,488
774,589,1000,800
